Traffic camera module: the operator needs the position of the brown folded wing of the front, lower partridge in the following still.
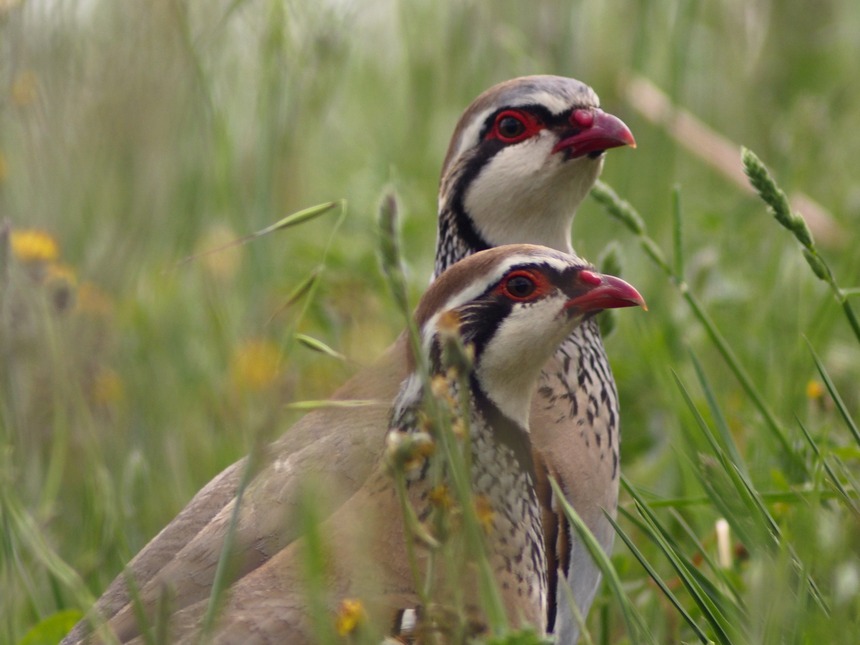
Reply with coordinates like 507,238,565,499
131,468,418,645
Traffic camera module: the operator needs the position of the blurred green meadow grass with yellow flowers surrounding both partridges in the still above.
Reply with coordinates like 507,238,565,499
0,0,860,643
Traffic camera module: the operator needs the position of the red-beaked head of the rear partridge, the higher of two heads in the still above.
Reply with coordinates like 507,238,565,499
436,76,636,273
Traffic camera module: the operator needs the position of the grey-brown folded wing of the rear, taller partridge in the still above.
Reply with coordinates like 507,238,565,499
63,337,407,645
